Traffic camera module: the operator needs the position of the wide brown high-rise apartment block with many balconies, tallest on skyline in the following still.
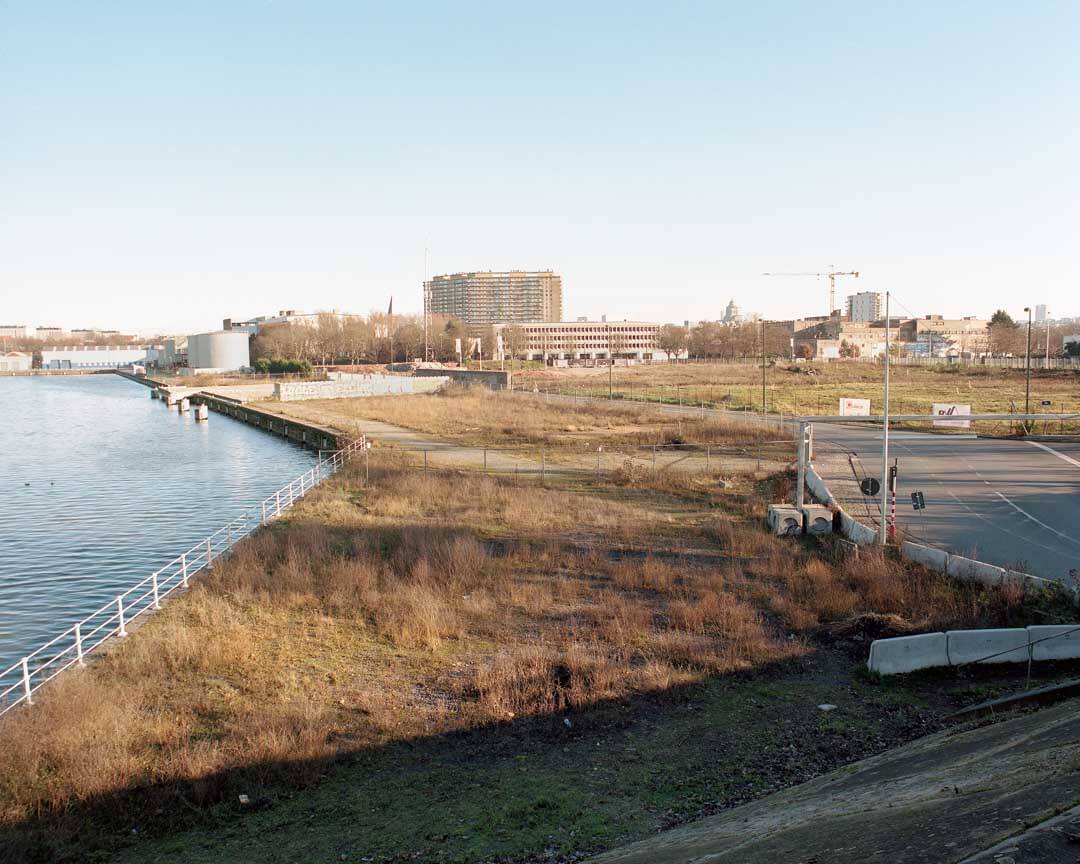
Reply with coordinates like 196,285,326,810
424,270,563,325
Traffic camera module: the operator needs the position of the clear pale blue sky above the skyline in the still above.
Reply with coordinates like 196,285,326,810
0,0,1080,330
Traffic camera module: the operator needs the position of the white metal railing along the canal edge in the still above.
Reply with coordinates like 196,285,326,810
0,438,364,715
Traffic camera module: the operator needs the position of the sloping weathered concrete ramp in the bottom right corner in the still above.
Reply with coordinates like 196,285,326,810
593,700,1080,864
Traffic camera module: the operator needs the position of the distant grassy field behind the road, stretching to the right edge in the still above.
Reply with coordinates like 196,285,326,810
515,362,1080,431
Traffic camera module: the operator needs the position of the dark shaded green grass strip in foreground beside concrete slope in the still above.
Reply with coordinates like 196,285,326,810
0,650,954,862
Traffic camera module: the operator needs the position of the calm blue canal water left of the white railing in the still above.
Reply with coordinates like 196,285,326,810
0,375,314,672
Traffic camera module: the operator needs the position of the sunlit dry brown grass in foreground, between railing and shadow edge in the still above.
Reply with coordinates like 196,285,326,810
0,457,1028,838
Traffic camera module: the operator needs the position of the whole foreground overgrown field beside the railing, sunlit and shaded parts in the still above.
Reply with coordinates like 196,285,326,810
0,451,1067,861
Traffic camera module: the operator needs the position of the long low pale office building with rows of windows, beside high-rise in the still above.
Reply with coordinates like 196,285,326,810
495,321,666,361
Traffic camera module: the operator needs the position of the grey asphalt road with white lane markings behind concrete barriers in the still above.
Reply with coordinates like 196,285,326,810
814,423,1080,580
